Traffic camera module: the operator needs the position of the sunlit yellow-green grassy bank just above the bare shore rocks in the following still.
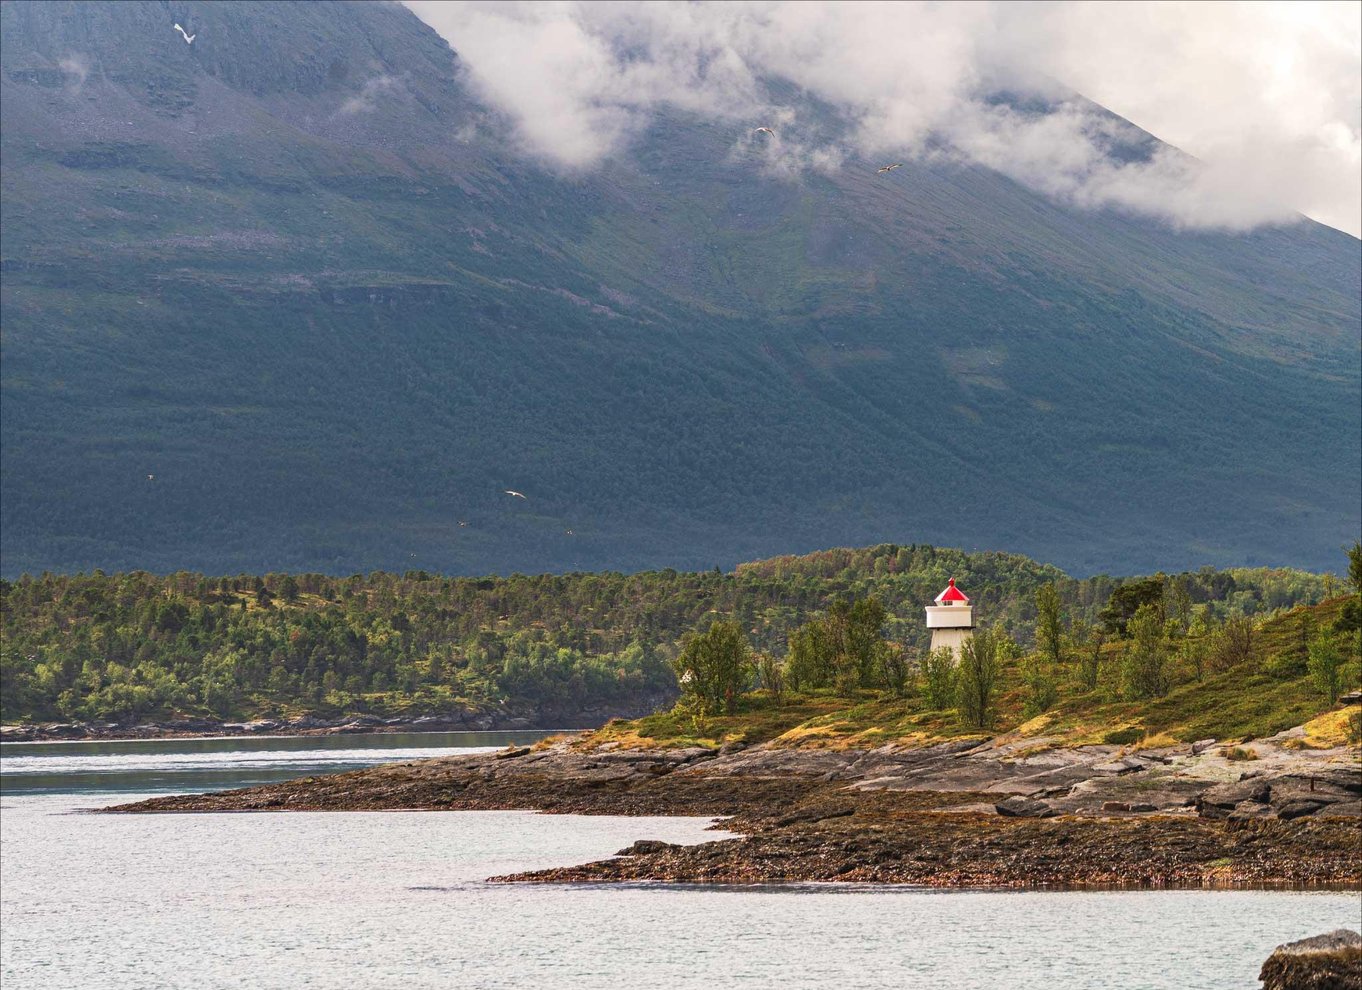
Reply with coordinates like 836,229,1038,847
582,598,1359,748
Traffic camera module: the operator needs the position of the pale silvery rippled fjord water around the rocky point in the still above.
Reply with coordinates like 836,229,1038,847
0,733,1358,990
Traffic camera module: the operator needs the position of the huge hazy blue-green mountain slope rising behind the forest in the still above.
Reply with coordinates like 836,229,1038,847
0,0,1362,575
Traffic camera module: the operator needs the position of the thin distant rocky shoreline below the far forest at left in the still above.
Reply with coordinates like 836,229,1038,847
0,701,652,742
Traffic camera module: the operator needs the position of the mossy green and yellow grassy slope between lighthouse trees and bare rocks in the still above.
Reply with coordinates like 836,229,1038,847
593,596,1362,761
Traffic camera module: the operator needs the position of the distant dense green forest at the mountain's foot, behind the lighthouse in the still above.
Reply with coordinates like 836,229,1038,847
0,545,1332,722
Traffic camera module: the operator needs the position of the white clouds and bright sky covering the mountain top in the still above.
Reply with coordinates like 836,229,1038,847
406,0,1362,237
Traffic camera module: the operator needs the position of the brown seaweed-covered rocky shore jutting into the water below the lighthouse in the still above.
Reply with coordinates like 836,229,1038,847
112,733,1362,888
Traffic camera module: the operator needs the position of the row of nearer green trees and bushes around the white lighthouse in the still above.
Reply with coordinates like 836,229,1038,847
673,543,1362,730
